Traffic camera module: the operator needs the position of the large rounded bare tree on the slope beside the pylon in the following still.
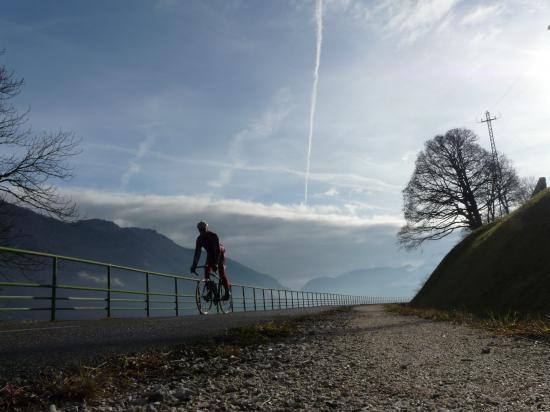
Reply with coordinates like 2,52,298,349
398,129,518,249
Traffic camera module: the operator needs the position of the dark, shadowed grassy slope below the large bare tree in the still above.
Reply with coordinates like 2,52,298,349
413,190,550,315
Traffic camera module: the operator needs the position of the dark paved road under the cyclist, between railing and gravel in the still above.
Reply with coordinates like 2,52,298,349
0,307,328,377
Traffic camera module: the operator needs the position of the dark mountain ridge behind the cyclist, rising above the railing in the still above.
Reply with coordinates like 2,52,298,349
2,204,285,289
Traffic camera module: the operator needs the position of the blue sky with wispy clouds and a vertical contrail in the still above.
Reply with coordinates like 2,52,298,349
0,0,550,293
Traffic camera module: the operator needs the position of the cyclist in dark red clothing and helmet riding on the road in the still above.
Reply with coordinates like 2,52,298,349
191,221,231,300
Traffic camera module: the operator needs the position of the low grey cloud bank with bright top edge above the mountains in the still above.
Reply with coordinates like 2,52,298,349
67,189,449,288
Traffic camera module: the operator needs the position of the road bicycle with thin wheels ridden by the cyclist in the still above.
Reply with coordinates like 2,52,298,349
195,266,233,315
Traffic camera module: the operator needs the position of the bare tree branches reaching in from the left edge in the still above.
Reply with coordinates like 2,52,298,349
0,53,79,243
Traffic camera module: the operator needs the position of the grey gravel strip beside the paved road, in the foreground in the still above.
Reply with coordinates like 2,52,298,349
4,306,550,412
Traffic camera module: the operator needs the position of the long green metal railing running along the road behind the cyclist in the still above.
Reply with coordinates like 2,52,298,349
0,247,410,321
